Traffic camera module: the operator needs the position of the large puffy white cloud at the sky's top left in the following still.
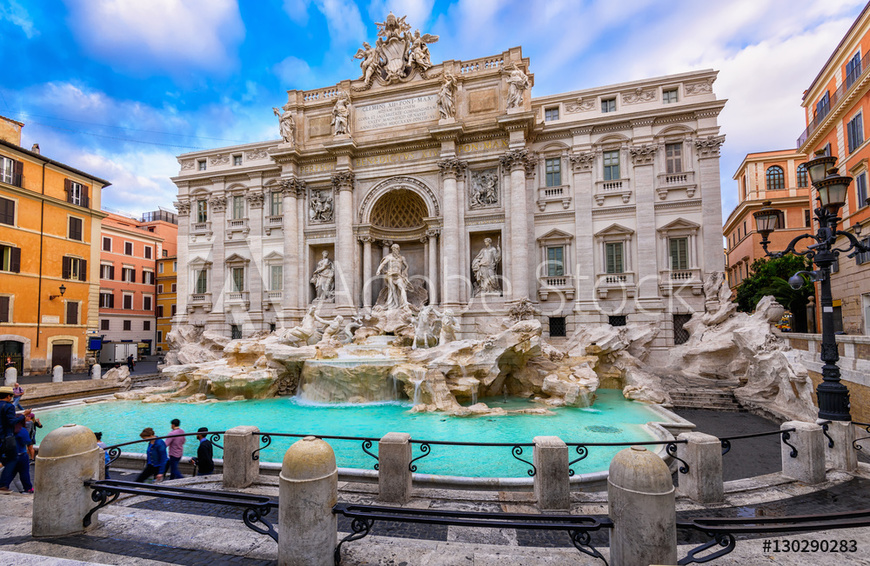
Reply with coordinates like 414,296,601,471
65,0,245,72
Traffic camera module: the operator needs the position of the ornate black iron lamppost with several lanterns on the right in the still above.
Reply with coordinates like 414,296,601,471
753,152,870,421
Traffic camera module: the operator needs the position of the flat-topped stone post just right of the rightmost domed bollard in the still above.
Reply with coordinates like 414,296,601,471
677,432,725,503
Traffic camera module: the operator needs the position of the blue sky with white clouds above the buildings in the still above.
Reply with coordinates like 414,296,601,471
0,0,864,216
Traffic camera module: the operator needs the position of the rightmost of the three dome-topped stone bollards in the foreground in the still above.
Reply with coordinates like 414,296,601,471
607,446,677,566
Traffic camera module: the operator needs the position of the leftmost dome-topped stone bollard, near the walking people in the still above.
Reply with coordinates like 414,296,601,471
31,424,102,537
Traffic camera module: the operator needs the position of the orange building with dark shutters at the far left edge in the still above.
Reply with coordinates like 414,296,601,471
0,117,110,373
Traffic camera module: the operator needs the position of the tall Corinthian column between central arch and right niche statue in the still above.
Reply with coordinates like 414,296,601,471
438,159,468,308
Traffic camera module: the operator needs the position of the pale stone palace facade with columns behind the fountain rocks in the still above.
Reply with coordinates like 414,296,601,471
173,18,725,356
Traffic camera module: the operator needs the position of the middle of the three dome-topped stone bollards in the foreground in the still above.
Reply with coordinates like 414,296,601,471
278,436,338,566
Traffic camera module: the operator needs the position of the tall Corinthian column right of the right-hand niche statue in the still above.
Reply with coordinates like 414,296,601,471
500,149,537,301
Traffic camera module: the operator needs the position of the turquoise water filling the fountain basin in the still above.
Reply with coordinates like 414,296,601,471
39,389,662,478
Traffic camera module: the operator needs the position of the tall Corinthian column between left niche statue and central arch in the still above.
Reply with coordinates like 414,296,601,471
332,171,355,314
